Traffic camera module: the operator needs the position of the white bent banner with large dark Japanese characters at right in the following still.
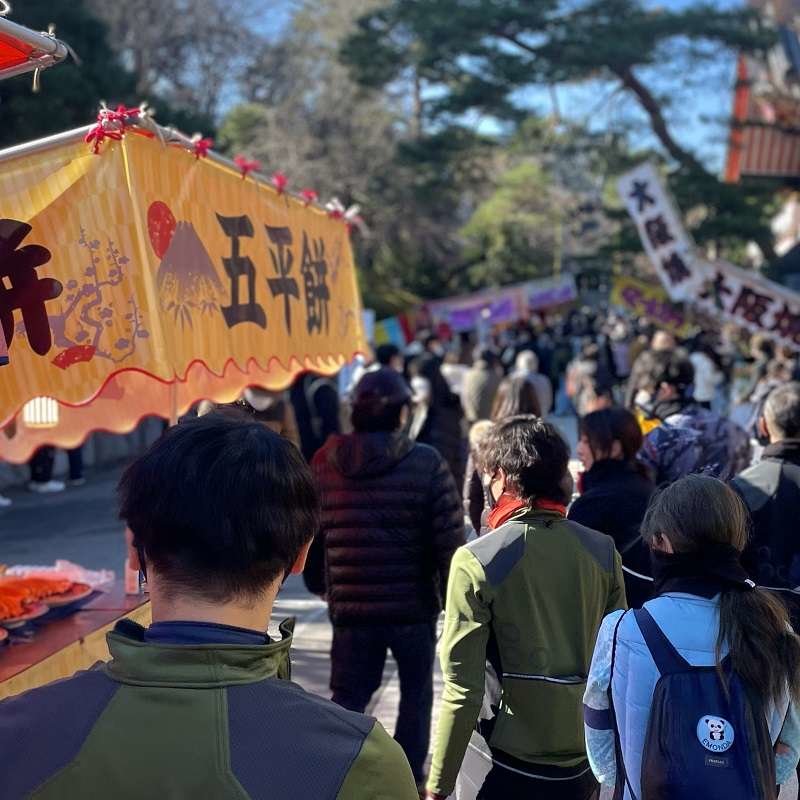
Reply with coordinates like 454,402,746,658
617,164,800,350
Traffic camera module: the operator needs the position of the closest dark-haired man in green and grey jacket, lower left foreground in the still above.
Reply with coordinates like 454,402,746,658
0,414,418,800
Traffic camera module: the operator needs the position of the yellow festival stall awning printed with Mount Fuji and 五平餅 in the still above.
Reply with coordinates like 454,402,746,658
0,129,366,463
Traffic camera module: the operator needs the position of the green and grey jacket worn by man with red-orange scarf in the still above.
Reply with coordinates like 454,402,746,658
428,509,625,796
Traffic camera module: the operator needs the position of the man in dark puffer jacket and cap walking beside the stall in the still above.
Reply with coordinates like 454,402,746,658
309,369,464,785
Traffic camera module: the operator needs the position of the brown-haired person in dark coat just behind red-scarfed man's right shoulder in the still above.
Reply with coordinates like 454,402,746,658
567,408,655,608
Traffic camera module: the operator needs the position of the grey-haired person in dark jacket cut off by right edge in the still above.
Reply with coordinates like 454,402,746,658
733,382,800,629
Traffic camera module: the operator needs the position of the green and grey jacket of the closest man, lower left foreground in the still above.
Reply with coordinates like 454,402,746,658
0,620,418,800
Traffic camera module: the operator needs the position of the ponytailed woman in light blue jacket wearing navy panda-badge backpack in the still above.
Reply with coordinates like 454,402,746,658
584,475,800,800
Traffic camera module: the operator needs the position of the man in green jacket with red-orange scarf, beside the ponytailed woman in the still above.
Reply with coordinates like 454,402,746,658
427,415,625,800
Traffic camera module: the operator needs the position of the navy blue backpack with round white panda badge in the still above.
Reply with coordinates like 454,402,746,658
608,608,776,800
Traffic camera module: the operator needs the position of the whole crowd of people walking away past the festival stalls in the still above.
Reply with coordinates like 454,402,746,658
0,311,800,800
